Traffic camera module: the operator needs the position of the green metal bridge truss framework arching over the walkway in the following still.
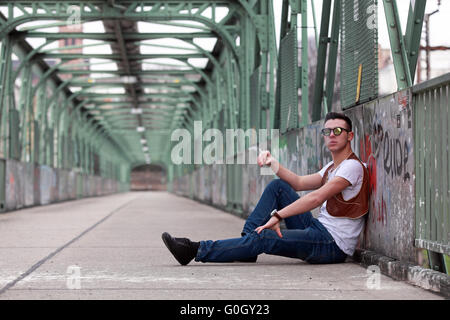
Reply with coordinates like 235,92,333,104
0,0,425,181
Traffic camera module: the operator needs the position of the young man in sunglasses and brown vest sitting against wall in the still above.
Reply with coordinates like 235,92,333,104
162,112,369,265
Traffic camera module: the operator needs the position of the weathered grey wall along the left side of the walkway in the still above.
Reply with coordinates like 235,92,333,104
2,159,129,211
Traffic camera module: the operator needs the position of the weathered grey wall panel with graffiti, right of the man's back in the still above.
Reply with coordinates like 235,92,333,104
361,91,415,261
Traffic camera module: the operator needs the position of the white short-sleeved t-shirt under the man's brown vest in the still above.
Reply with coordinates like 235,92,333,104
318,159,364,256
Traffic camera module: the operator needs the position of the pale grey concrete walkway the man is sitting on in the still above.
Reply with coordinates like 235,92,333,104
0,192,442,300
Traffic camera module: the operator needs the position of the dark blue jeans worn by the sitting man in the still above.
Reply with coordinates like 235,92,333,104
195,179,347,263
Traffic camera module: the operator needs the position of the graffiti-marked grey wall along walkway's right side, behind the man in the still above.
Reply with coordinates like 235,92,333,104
172,90,417,262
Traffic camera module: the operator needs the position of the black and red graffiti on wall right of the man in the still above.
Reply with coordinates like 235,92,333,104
359,94,412,226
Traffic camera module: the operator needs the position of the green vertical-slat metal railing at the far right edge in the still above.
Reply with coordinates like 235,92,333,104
412,73,450,255
